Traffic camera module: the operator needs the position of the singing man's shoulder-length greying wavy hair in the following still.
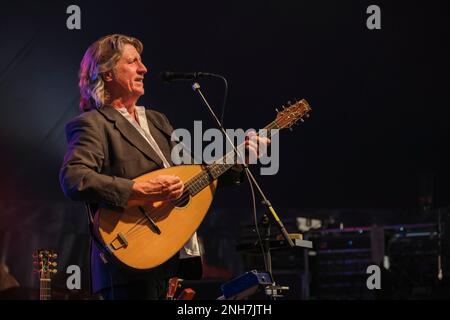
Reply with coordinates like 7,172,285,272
78,34,143,112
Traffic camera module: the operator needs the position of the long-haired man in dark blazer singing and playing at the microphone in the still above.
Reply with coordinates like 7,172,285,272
60,34,270,299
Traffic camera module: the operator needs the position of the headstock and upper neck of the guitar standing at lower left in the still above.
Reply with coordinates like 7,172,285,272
33,249,58,300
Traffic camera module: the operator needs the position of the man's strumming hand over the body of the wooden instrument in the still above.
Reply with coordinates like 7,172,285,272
128,175,184,205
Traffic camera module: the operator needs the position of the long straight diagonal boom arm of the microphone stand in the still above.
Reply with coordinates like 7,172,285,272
192,82,295,248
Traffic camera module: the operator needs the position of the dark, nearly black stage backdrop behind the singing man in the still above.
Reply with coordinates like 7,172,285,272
0,0,450,298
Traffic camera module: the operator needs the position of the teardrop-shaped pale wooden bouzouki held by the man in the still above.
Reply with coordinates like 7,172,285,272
94,100,311,270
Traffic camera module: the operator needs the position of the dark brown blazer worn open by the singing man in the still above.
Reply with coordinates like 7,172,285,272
59,106,242,292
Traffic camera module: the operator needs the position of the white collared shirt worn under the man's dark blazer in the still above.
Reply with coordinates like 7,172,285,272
115,106,200,259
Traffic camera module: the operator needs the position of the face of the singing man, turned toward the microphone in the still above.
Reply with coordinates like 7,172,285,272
109,44,147,98
